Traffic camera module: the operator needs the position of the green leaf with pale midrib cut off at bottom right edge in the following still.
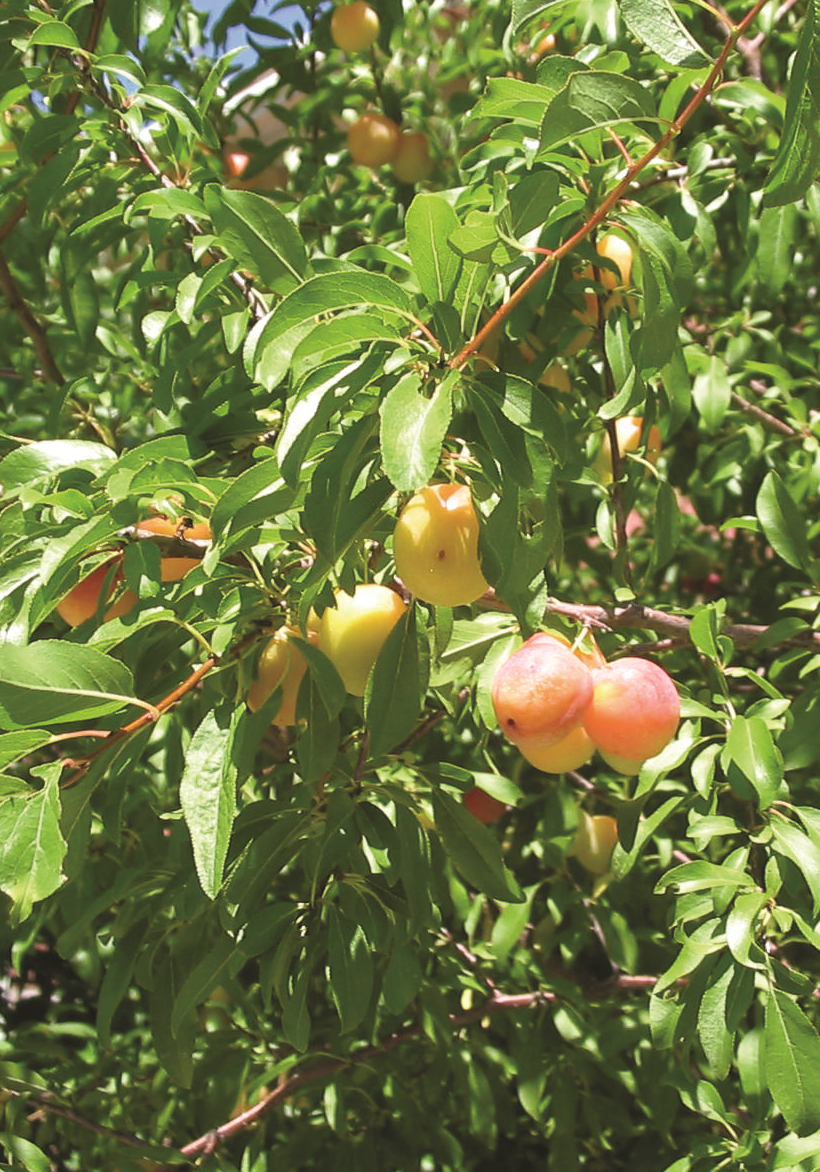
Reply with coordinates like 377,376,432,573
764,989,820,1134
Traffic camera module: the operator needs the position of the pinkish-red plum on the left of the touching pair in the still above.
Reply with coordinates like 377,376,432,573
492,633,593,749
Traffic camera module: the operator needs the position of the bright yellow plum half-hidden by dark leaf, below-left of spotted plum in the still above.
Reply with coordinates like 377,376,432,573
319,582,406,696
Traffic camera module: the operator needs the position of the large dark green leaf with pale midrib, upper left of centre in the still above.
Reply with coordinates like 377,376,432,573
205,183,310,294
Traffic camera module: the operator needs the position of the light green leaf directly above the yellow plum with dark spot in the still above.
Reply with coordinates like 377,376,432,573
380,374,452,492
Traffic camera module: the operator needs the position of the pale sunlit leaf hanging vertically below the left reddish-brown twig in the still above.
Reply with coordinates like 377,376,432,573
179,704,242,899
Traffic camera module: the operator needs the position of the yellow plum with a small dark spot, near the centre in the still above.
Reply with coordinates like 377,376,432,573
392,484,488,606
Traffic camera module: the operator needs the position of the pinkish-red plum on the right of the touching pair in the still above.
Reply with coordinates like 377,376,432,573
583,655,681,768
